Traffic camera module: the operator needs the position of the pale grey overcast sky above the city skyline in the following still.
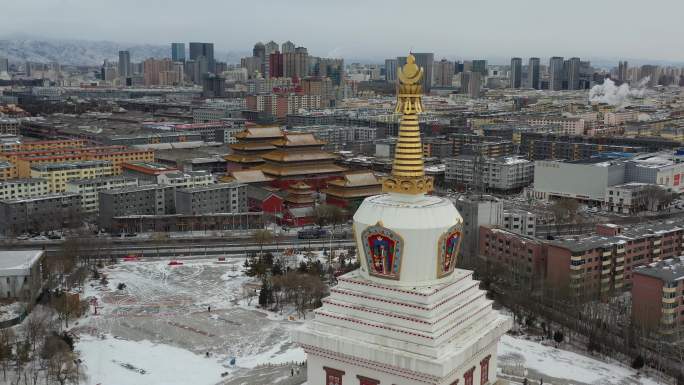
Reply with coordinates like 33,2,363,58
0,0,684,61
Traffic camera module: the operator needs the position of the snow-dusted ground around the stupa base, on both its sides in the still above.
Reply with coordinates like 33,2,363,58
70,259,657,385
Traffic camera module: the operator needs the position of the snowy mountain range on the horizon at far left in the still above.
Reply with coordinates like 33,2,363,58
0,37,171,65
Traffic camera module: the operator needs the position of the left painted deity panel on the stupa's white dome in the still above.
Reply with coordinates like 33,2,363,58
361,225,404,279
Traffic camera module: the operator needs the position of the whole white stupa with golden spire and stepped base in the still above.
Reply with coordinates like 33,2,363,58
294,55,511,385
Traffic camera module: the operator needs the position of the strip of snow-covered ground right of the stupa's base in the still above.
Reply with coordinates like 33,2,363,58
498,335,658,385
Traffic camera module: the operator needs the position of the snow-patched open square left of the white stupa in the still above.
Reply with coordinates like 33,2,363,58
74,259,305,385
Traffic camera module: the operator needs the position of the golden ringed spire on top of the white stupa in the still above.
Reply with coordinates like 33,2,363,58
382,54,433,195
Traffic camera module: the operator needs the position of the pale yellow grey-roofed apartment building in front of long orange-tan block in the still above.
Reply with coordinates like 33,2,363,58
31,160,114,193
